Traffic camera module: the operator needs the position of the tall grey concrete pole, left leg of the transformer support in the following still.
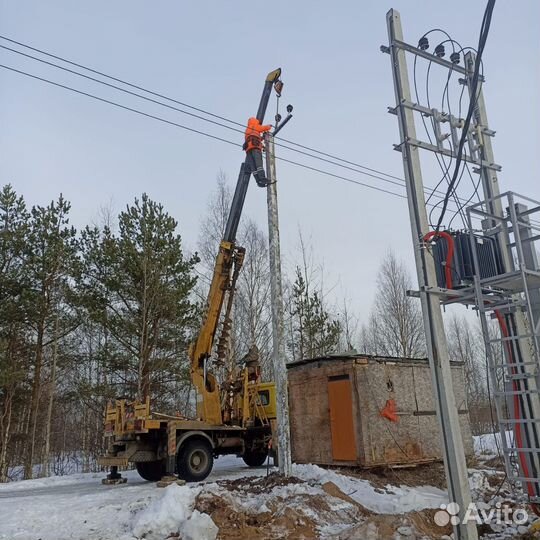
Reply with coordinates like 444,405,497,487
385,9,478,540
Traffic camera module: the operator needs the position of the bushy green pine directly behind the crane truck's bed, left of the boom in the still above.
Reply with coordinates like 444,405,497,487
81,194,198,402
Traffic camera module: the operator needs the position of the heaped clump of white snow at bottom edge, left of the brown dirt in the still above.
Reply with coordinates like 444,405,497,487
133,484,218,540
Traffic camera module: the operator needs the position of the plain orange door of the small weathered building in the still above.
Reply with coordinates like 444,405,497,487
328,376,357,461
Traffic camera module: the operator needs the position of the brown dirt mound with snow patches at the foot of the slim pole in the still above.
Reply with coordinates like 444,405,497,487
195,475,460,540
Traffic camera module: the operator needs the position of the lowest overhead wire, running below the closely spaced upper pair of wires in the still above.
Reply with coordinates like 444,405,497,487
0,64,466,211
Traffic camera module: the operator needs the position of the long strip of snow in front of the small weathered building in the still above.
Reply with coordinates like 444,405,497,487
293,465,448,514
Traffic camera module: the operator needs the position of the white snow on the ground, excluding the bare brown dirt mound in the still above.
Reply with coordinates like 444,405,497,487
0,456,452,540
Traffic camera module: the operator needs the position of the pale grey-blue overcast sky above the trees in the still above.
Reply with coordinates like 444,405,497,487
0,0,540,317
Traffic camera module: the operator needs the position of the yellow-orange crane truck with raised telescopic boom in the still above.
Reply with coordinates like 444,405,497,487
98,68,283,483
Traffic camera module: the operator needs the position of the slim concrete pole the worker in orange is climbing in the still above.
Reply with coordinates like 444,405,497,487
266,134,291,476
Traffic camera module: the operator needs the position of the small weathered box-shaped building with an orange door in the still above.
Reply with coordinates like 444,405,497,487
288,354,473,467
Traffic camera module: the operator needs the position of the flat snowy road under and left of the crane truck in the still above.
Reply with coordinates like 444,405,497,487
0,456,266,540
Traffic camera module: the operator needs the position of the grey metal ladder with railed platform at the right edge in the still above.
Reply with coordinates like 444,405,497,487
467,192,540,502
